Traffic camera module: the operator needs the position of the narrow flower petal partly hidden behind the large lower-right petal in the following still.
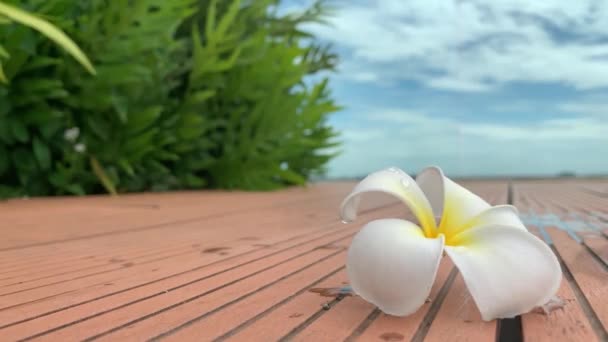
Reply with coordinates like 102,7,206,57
446,204,528,246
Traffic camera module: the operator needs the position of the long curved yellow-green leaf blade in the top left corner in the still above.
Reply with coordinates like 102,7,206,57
0,2,95,75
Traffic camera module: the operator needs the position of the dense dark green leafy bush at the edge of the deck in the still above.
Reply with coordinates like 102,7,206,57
0,0,339,197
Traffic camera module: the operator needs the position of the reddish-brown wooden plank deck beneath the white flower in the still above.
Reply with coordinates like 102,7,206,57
0,180,608,342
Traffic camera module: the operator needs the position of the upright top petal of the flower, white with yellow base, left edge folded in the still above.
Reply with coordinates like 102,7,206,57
416,166,490,236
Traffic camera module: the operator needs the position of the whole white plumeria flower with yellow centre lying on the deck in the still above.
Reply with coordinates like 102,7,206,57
341,167,562,321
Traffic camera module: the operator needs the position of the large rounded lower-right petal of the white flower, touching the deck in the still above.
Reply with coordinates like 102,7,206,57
445,226,562,321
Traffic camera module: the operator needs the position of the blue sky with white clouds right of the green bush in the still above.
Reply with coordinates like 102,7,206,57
284,0,608,177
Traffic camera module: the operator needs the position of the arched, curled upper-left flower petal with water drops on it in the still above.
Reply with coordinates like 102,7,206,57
341,168,437,236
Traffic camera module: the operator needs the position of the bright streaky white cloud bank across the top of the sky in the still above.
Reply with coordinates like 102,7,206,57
309,0,608,92
